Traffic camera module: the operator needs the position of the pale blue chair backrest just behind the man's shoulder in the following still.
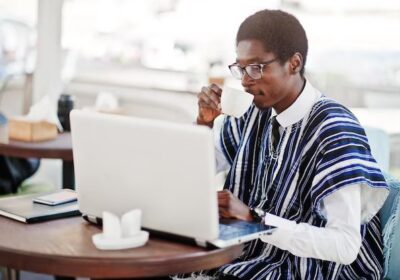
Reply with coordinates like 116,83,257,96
364,126,390,172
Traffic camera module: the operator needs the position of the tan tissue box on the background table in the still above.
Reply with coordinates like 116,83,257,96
8,119,58,142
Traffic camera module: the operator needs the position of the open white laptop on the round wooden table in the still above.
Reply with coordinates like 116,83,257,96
70,110,273,247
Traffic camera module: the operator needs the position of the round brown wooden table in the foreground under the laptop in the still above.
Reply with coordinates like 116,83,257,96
0,216,243,278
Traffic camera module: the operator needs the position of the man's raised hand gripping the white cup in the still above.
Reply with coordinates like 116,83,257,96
197,84,222,127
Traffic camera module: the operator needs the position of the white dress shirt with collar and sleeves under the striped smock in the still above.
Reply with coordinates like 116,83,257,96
215,82,369,264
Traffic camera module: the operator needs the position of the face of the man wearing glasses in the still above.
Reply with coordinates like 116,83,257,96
236,40,298,113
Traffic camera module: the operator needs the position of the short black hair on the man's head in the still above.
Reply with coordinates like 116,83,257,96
236,10,308,76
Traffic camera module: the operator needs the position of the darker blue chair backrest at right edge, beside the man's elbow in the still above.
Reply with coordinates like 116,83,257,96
379,175,400,279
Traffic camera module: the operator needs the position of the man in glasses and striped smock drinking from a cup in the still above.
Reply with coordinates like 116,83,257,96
197,10,388,279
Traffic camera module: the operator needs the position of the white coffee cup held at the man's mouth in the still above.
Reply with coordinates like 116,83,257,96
221,87,254,118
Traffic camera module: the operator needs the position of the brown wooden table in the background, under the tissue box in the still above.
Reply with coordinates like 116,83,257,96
0,132,75,189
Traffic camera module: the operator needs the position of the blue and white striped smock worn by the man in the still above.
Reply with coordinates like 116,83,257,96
217,96,387,279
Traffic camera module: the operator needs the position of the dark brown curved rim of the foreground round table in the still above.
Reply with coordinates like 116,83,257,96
0,244,243,278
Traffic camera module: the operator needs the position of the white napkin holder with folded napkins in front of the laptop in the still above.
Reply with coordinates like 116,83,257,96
92,209,149,250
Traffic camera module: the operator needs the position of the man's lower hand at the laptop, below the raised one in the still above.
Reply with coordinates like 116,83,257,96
218,190,253,222
